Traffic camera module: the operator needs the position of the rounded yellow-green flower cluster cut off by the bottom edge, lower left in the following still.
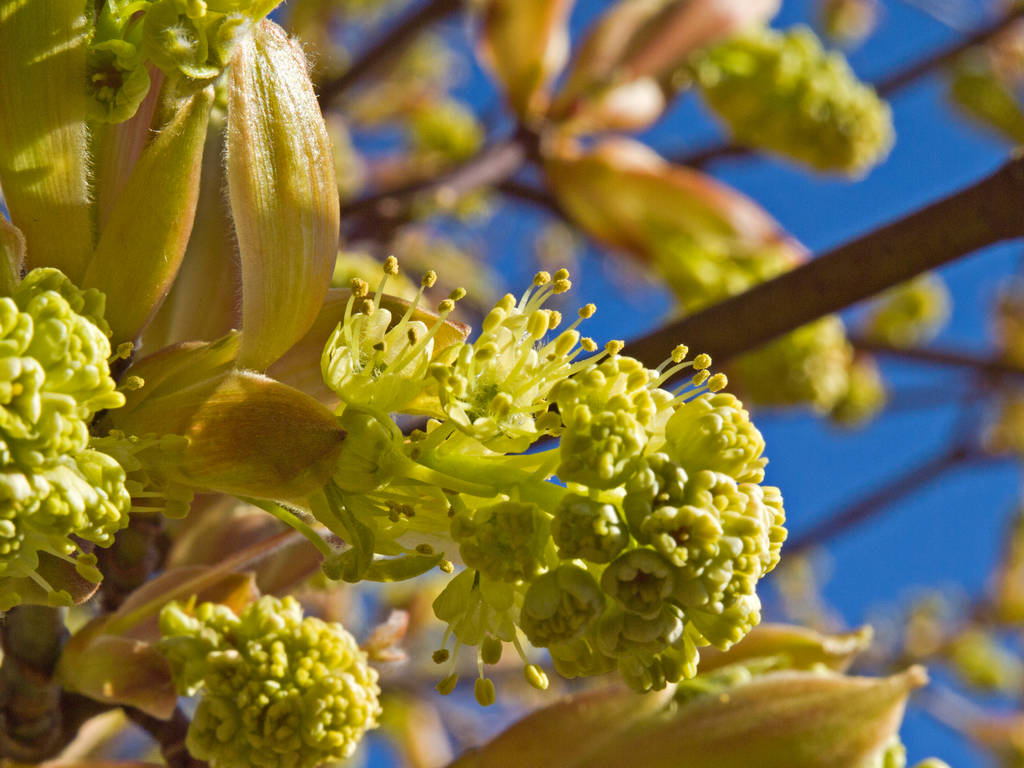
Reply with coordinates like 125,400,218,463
160,597,381,768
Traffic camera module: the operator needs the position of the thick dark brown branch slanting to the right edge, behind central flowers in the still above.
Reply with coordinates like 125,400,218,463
626,156,1024,365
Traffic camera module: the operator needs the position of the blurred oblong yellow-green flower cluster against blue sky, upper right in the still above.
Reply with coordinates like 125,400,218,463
693,27,893,174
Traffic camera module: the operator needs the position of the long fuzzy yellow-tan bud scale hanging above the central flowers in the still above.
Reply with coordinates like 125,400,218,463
227,22,339,371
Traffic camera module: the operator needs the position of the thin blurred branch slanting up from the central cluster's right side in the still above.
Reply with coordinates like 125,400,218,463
782,446,984,556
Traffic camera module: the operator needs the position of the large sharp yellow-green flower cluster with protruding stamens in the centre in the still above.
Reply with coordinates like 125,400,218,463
313,263,785,705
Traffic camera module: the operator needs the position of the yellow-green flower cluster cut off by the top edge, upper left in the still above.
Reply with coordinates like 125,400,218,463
87,0,279,123
